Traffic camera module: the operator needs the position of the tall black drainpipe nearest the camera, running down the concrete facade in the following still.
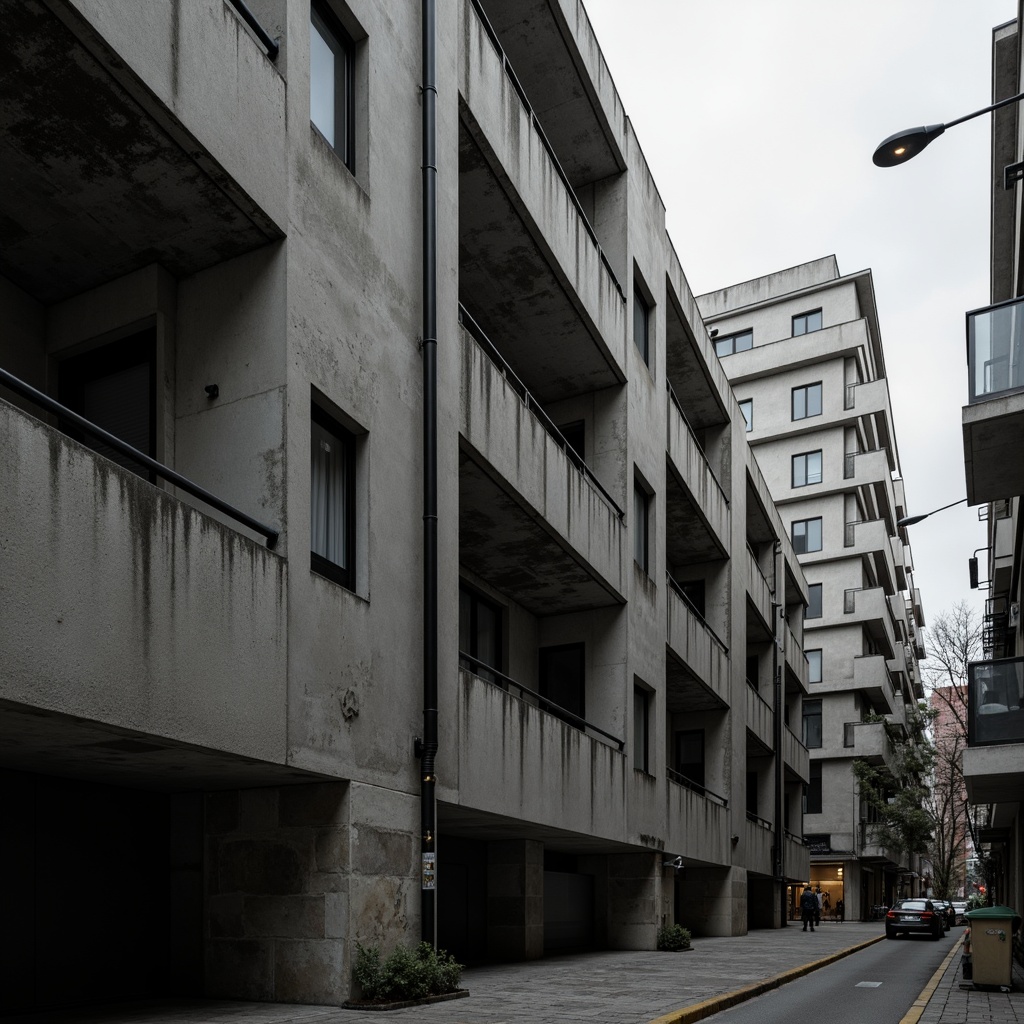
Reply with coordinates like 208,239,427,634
417,0,437,945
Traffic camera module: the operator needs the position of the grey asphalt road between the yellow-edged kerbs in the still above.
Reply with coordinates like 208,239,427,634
715,928,963,1024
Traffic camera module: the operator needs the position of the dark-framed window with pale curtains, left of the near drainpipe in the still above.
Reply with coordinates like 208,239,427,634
309,406,355,590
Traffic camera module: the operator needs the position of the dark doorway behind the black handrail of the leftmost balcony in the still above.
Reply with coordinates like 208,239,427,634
57,329,157,481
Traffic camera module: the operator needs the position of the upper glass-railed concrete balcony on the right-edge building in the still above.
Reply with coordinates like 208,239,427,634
963,299,1024,505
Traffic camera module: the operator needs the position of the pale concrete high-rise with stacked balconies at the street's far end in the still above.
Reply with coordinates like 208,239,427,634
697,257,924,918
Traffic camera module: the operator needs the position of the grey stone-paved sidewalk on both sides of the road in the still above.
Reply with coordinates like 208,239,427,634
5,922,1024,1024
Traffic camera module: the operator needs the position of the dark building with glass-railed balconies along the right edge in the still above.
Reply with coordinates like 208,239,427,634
949,4,1024,921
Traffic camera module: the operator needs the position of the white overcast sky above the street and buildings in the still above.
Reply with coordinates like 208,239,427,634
584,0,1016,620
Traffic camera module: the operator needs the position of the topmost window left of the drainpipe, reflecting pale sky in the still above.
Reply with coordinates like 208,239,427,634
309,0,355,171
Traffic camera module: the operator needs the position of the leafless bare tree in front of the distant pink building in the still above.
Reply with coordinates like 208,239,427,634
924,601,982,899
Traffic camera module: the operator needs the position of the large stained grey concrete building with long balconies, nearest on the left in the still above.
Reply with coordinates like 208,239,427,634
0,0,815,1010
